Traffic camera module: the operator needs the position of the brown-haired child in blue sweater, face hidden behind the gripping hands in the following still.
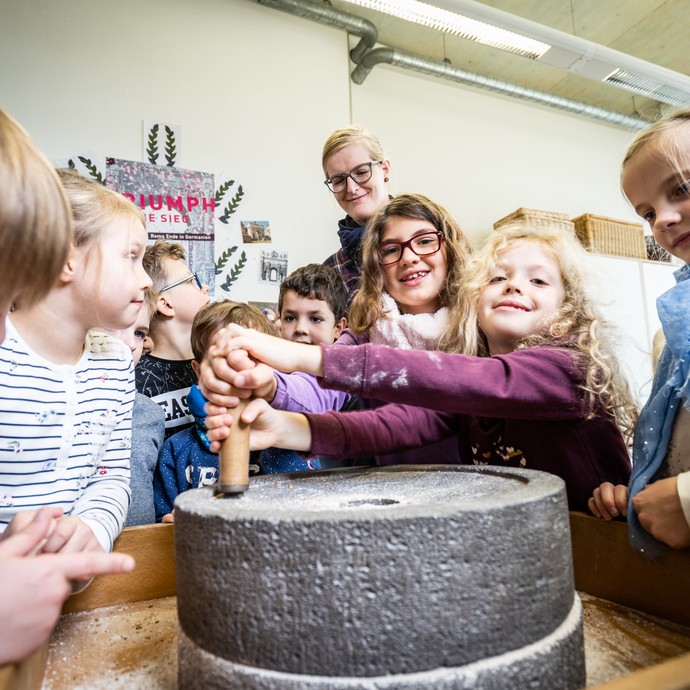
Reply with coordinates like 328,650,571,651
154,298,312,522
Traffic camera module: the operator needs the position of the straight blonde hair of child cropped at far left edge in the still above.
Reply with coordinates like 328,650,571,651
0,109,72,307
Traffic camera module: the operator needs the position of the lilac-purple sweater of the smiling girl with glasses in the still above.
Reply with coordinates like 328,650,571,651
271,328,460,465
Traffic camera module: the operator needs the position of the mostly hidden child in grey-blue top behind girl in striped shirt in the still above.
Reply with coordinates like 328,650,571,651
99,290,165,527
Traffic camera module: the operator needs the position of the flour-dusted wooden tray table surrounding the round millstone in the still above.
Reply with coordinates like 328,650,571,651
0,513,690,690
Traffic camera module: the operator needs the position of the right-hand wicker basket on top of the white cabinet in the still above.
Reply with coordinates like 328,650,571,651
573,213,647,259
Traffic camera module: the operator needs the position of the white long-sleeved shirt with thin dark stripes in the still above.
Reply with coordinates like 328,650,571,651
0,319,134,551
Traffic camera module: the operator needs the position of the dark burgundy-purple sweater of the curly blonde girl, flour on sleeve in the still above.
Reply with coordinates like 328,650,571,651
307,345,630,511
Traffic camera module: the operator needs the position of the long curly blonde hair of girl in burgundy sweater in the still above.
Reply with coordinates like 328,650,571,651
452,223,637,441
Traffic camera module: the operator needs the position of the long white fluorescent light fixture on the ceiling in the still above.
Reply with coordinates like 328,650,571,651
338,0,690,105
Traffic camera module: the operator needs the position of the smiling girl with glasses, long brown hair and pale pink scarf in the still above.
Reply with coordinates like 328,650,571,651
201,194,470,465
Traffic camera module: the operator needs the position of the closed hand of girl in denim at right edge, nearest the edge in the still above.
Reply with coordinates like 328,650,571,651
632,477,690,549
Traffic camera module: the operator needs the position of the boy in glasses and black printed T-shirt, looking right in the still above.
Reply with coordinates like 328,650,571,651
136,240,208,438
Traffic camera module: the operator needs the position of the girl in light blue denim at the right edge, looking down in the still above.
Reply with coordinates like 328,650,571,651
589,108,690,556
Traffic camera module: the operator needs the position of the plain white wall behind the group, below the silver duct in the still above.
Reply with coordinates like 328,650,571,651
0,0,670,398
